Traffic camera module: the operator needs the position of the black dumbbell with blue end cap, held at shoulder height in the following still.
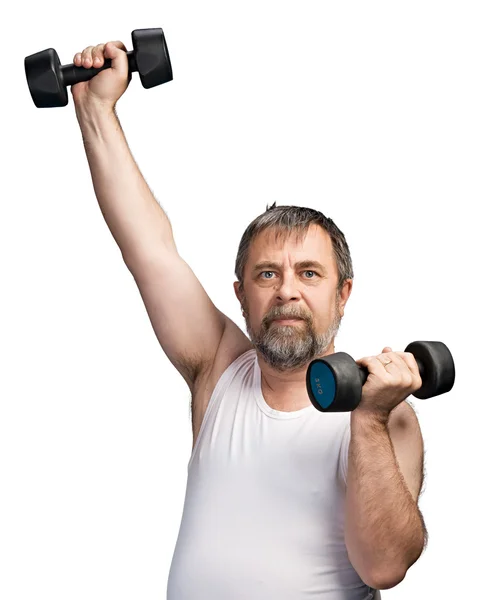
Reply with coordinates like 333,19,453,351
306,342,455,412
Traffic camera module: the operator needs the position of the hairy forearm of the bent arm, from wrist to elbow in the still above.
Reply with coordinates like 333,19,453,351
345,411,424,589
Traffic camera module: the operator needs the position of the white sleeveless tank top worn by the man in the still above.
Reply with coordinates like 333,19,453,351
167,349,380,600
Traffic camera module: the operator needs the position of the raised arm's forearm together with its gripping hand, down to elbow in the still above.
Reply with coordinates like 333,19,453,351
72,42,176,267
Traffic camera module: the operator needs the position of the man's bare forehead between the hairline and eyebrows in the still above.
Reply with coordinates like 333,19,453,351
248,224,333,265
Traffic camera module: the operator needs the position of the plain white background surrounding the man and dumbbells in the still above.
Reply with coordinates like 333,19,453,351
0,0,494,600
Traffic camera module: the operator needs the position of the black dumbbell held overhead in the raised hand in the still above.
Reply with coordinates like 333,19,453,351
24,28,173,108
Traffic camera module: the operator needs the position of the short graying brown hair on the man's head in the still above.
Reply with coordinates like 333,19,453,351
235,202,353,293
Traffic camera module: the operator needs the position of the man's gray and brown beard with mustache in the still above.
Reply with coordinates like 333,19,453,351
244,307,341,372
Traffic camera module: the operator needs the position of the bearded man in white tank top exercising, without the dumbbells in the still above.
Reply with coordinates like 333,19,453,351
72,42,427,600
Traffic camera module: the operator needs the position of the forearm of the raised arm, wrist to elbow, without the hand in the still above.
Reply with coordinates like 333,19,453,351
76,105,176,265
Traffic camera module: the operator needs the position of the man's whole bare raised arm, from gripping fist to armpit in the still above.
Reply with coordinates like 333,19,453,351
71,42,243,390
